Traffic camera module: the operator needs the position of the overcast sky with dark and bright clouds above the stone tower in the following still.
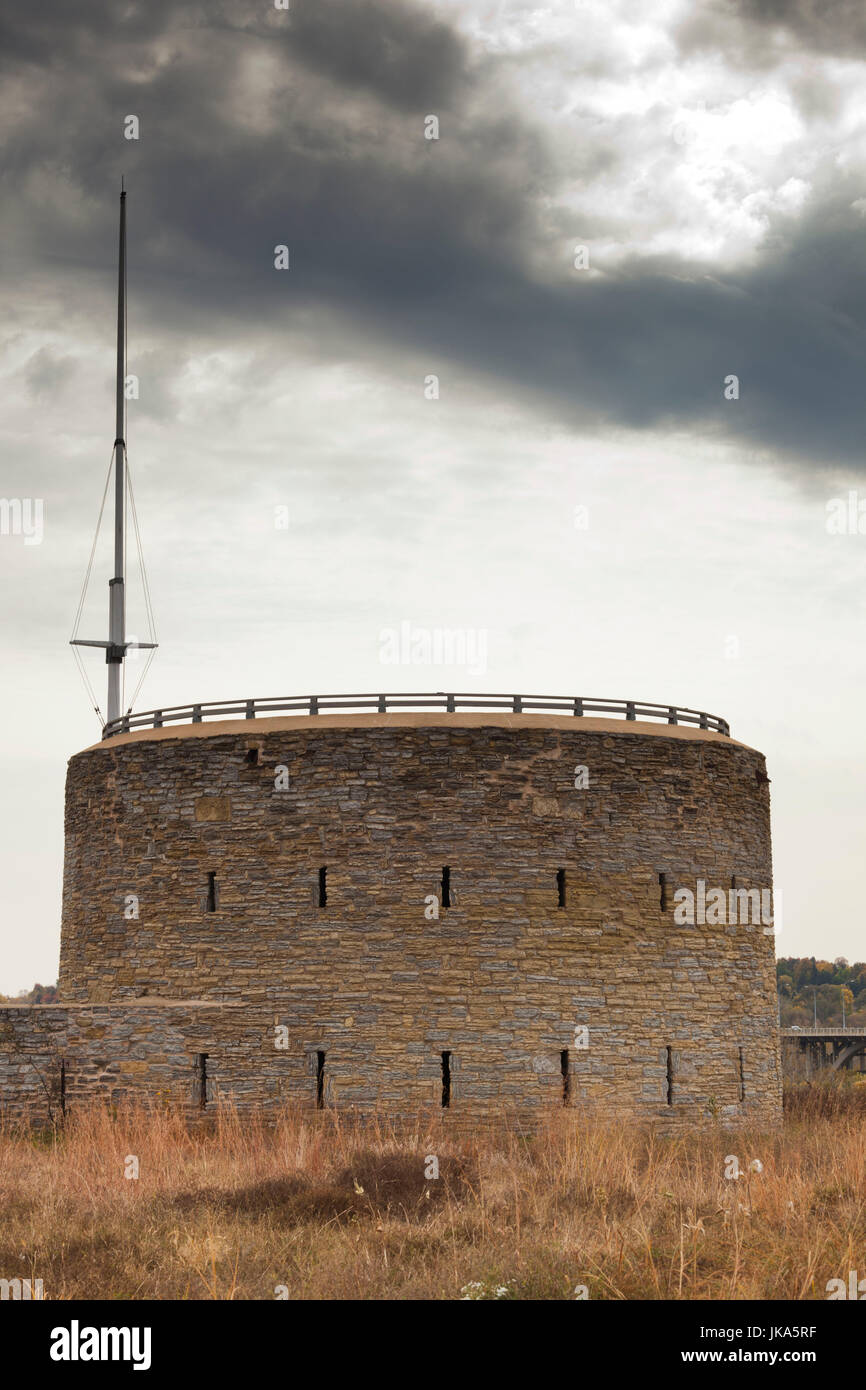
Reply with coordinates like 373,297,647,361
0,0,866,992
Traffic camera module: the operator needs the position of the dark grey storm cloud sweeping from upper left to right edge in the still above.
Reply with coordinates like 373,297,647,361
3,0,866,467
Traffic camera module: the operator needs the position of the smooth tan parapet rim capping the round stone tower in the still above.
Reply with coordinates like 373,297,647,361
82,710,758,753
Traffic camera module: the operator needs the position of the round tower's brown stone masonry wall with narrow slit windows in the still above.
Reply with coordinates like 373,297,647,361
38,716,781,1123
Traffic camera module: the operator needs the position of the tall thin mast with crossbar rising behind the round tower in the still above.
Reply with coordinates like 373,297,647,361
71,190,157,724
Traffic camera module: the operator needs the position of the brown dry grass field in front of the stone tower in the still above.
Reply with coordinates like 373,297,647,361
0,1084,866,1300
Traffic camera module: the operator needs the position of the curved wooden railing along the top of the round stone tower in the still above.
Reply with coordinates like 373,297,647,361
103,691,731,738
